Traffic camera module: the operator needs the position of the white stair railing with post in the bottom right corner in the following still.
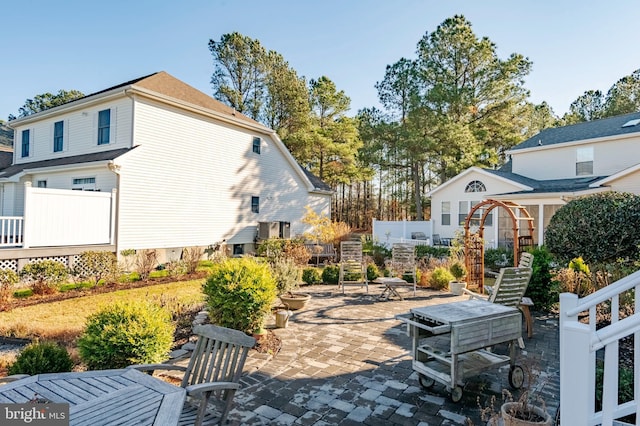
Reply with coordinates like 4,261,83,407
560,271,640,426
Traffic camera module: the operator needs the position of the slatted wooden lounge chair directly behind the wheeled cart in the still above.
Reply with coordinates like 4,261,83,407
463,267,533,348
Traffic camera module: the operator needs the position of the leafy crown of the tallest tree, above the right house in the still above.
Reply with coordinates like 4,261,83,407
414,15,531,182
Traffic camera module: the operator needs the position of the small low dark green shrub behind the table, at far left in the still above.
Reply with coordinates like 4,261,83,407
8,342,73,376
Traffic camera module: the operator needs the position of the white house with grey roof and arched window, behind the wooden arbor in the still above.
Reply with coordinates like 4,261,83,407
429,113,640,247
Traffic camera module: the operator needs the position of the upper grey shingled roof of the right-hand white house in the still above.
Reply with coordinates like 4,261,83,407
508,112,640,152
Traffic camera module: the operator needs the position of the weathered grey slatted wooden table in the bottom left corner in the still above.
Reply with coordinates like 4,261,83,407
0,369,186,426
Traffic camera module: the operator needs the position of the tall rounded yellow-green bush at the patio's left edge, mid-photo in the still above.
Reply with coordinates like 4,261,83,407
203,257,277,333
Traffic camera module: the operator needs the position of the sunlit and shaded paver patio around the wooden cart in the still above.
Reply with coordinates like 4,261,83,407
181,284,559,426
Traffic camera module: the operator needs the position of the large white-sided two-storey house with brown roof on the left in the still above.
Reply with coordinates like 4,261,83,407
5,72,332,257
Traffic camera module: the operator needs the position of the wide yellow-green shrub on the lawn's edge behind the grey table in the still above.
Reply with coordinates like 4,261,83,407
78,301,175,370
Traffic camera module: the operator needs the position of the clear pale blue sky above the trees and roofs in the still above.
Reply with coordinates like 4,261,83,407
0,0,640,120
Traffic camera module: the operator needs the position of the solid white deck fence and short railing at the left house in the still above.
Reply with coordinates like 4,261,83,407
14,184,116,248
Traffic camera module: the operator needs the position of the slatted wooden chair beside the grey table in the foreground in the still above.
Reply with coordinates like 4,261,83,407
129,324,256,426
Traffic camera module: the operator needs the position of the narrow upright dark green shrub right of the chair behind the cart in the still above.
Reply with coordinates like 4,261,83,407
525,246,559,311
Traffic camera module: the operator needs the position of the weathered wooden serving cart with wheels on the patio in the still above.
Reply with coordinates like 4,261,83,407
396,300,524,402
